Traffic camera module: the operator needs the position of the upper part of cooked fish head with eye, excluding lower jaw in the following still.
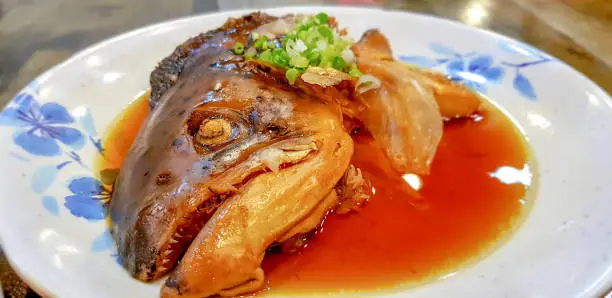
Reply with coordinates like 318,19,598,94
110,57,353,280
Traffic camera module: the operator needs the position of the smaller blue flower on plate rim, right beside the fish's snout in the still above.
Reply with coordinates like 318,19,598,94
64,177,111,221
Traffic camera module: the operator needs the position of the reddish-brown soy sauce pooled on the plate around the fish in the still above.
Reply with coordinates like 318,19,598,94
96,95,534,293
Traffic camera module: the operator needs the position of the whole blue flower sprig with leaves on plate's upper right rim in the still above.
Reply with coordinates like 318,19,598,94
400,42,552,100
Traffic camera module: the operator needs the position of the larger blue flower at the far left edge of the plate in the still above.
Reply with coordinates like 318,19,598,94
0,93,85,156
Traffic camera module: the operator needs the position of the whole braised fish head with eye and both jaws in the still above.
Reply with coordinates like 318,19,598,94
110,14,353,297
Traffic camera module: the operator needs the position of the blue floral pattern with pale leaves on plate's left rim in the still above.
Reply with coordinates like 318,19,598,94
0,81,117,258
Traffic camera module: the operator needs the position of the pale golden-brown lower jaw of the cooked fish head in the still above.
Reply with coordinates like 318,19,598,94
161,104,353,297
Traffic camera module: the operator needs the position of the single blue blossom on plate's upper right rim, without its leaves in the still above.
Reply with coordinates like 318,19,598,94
446,54,505,93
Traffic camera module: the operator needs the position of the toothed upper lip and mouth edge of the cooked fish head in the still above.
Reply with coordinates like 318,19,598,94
111,133,320,281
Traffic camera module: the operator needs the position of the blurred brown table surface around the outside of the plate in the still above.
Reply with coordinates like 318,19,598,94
0,0,612,298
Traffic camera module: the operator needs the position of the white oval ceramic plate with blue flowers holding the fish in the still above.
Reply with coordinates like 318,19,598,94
0,7,612,298
